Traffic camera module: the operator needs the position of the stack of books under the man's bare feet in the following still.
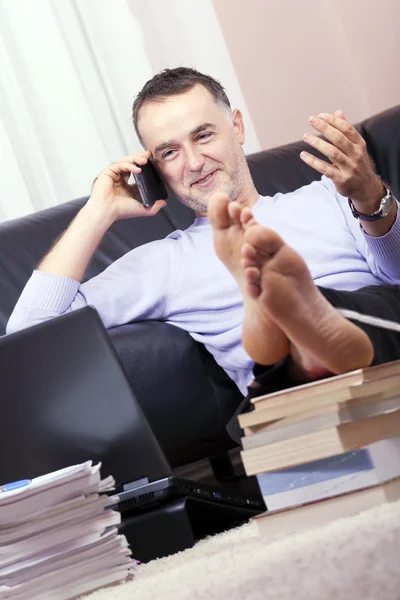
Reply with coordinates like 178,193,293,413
239,361,400,534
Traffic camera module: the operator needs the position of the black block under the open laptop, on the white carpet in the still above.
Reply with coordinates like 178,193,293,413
119,496,260,563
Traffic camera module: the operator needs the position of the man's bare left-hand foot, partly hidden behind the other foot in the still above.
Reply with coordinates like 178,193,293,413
207,193,289,365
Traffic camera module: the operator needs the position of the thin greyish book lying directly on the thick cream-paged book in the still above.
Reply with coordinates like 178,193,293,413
242,395,400,450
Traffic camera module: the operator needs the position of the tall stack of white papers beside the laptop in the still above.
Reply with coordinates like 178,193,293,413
0,461,136,600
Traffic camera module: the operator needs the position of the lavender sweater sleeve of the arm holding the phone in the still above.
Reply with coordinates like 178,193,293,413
6,238,175,333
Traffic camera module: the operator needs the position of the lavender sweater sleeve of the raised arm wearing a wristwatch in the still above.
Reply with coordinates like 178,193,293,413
321,177,400,285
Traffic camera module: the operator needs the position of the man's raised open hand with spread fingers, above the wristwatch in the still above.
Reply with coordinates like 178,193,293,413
300,110,386,214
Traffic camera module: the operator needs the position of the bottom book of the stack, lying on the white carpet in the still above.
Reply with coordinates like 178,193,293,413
255,478,400,538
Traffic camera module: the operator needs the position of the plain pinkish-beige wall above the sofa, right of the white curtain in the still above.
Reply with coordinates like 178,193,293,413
214,0,400,148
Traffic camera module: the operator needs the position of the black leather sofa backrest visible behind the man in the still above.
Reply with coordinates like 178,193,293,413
0,106,400,335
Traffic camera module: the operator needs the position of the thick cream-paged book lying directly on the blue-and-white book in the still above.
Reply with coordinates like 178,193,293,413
241,410,400,475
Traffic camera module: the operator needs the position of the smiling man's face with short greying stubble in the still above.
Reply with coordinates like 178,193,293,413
139,85,246,215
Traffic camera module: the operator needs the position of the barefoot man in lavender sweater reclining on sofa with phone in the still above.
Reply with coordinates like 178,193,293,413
7,67,400,426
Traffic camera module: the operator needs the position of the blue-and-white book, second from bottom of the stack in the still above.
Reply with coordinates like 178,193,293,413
257,437,400,510
